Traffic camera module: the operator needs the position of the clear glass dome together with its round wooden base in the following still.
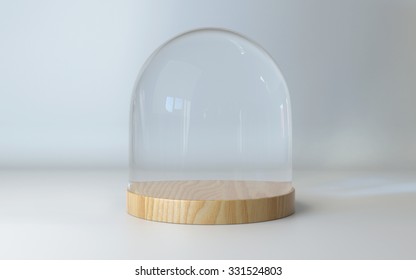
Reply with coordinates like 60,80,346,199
128,29,294,224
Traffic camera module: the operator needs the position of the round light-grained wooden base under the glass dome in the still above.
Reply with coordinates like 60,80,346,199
127,181,295,224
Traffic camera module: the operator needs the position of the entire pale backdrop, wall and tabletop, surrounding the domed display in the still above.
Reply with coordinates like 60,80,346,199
0,0,416,259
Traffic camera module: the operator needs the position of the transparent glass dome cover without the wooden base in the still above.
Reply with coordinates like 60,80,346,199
130,29,292,186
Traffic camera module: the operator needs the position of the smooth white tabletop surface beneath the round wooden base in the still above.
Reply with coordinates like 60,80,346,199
0,169,416,259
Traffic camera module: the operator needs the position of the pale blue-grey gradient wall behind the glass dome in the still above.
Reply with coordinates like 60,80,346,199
0,0,416,168
